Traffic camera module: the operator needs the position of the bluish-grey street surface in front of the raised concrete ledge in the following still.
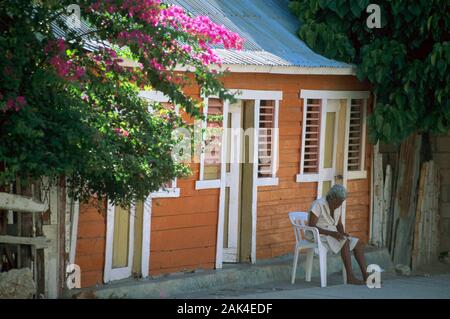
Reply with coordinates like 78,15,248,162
181,263,450,299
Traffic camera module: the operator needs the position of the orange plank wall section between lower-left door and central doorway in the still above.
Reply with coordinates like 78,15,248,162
149,164,219,275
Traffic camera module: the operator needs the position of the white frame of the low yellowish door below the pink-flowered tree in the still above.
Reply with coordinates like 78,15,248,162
103,202,136,283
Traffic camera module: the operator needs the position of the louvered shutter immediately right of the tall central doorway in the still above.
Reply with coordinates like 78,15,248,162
258,100,275,177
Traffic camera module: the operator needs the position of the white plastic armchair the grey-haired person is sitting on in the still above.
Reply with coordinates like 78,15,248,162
289,212,347,287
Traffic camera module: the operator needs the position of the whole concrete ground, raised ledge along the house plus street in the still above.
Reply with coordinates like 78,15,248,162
66,248,450,299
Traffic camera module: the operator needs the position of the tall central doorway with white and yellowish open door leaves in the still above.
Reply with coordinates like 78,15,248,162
222,100,255,263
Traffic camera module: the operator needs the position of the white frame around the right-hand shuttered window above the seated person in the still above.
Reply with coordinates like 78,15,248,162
296,90,370,183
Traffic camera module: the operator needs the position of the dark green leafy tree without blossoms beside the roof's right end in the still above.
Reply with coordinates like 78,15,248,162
290,0,450,143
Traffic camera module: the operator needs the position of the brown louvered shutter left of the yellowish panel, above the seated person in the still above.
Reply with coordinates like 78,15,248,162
303,99,322,174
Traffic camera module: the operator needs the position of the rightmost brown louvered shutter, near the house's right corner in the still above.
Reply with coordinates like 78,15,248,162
347,99,364,171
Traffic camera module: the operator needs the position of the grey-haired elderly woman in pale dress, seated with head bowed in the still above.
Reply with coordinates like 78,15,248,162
307,184,368,285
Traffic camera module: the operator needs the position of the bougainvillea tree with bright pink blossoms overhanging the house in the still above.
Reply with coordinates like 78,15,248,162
0,0,242,204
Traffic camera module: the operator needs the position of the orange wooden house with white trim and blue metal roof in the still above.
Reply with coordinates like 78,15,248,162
70,0,372,287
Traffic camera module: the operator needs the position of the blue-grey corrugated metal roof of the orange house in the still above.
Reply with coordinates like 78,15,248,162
164,0,351,68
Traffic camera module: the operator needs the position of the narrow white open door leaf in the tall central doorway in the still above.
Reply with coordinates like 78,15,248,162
223,101,242,262
